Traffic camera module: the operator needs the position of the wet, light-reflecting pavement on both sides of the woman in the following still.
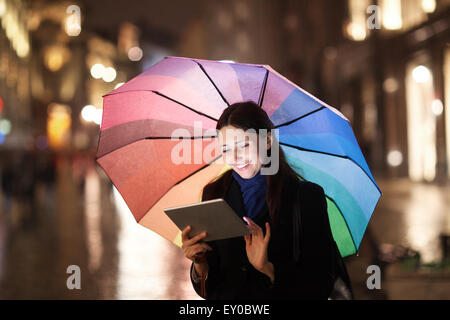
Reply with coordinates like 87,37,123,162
0,158,450,299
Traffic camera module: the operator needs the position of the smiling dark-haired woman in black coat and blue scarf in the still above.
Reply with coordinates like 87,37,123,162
182,102,351,299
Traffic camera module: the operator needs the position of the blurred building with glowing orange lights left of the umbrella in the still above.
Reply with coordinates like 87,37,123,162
0,0,147,153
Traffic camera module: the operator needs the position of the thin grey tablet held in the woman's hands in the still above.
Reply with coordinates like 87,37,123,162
164,198,250,241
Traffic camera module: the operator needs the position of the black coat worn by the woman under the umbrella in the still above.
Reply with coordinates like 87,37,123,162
191,172,352,300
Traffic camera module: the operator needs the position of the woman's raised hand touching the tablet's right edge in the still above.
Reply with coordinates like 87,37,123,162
244,217,274,281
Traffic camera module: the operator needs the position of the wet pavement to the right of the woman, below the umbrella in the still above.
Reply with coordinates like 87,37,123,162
345,179,450,300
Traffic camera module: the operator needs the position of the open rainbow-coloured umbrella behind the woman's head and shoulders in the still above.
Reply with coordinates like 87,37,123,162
96,57,381,257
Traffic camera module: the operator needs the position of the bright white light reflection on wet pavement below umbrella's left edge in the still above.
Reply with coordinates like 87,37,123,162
113,188,200,299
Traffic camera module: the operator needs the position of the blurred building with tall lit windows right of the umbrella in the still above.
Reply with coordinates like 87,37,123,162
322,0,450,181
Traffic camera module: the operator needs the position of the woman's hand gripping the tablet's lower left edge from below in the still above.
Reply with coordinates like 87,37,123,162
181,226,212,271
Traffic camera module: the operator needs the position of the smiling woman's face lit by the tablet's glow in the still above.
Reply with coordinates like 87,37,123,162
219,126,271,179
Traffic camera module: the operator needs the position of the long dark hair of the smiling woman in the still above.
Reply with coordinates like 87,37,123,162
203,101,300,226
